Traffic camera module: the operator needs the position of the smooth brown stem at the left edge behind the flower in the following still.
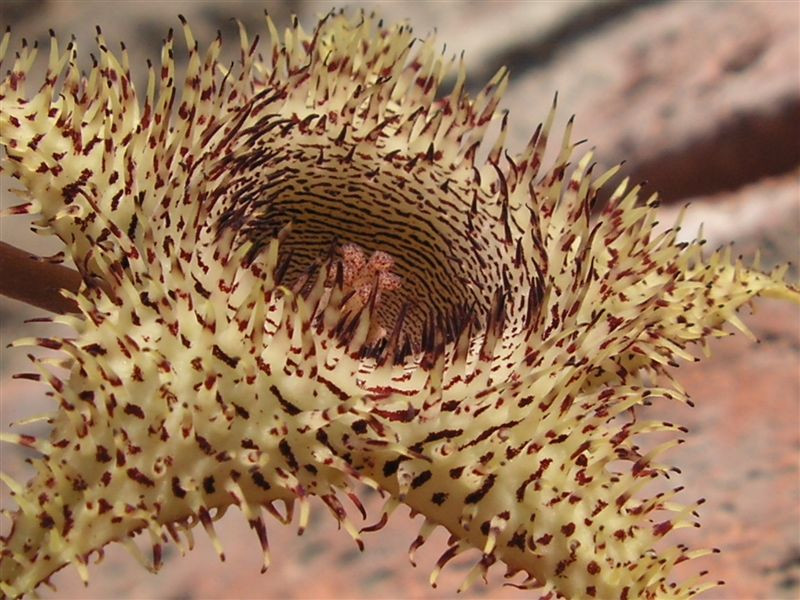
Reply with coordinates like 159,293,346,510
0,242,81,314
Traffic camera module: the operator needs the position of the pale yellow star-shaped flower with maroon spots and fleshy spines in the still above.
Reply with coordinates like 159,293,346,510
0,14,800,598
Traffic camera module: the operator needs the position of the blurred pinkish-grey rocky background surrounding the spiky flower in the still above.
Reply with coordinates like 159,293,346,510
0,0,800,600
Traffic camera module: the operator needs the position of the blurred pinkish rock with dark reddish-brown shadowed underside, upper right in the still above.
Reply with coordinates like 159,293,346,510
506,2,800,199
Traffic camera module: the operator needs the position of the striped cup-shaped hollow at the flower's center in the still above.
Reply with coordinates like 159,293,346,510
209,109,517,350
